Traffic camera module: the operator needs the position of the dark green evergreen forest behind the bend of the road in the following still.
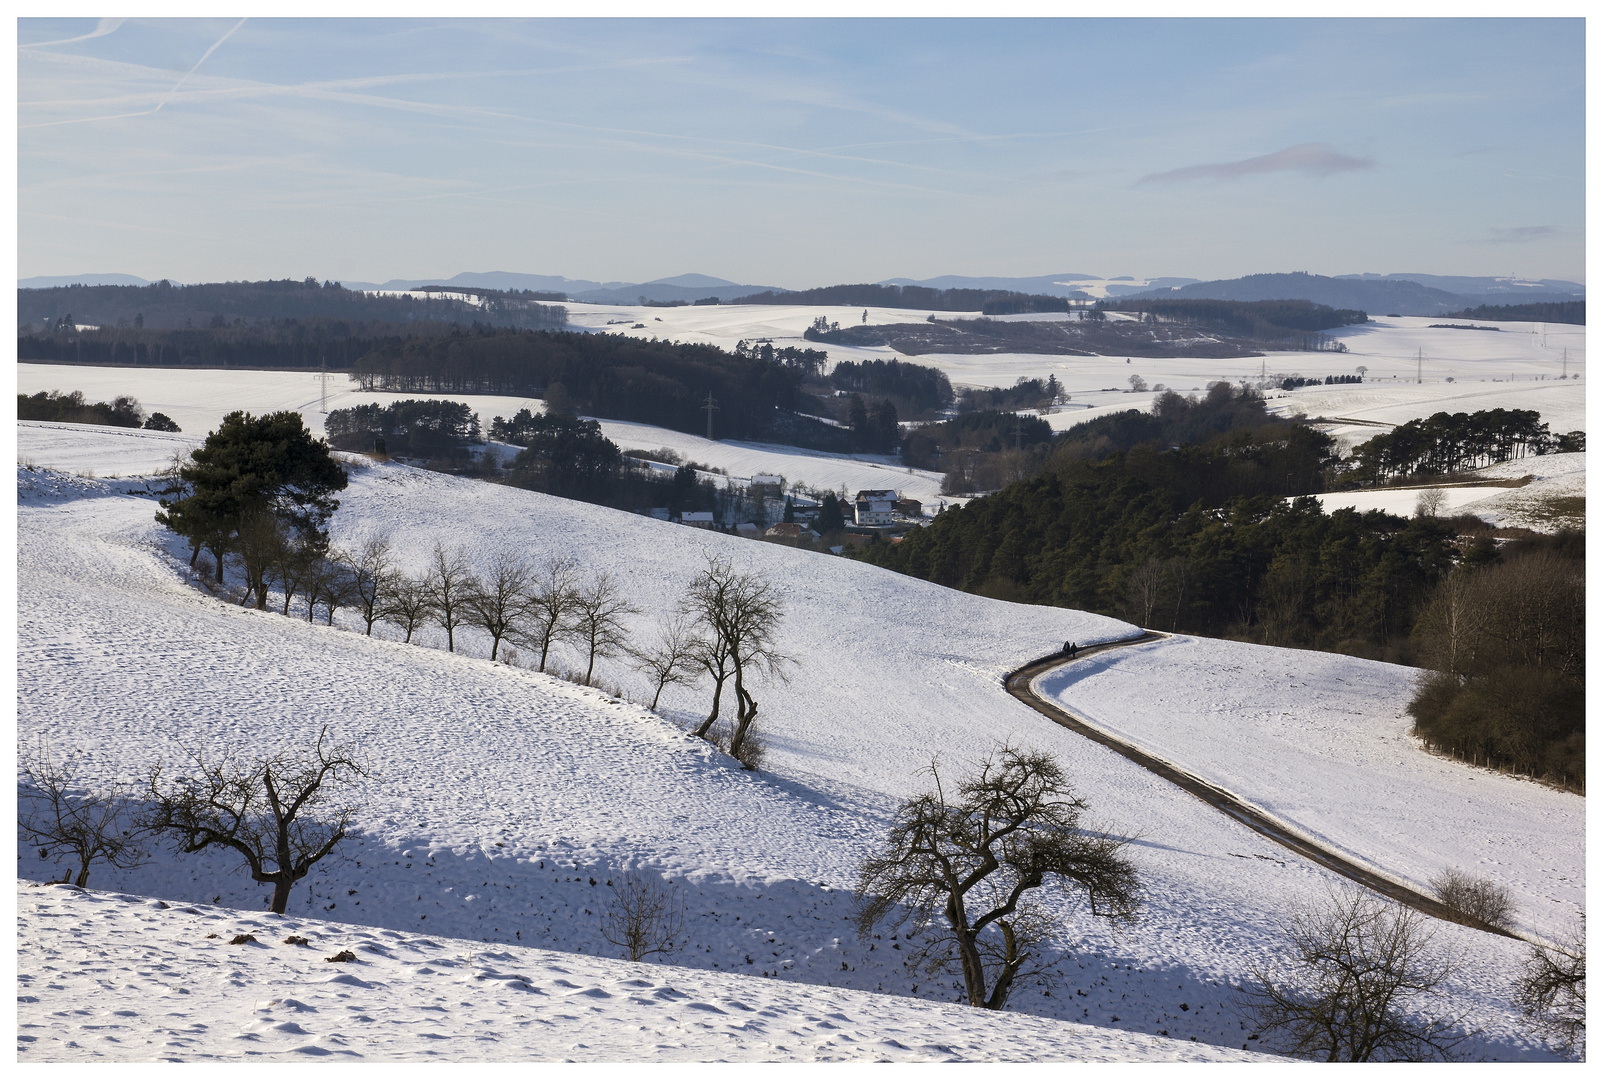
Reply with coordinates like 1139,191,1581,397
859,405,1456,657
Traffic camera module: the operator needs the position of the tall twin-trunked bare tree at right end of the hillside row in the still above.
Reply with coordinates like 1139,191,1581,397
684,554,789,758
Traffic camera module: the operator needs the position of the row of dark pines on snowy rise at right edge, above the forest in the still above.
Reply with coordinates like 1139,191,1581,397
1342,409,1585,486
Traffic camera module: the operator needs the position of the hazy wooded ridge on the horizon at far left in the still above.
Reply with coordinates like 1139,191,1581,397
16,277,567,336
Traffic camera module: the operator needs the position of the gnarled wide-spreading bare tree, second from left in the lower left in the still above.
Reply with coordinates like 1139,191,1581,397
149,727,369,915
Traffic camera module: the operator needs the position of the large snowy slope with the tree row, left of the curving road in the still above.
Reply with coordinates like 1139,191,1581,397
18,431,1564,1059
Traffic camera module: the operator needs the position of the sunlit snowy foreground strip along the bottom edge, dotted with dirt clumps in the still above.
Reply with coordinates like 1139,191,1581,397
18,885,1263,1062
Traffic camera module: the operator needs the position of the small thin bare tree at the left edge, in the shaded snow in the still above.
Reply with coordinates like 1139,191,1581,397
18,744,149,888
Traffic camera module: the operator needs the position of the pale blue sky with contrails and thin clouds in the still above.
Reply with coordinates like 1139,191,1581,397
18,19,1585,288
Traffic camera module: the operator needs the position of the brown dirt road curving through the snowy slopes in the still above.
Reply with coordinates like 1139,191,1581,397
1003,630,1521,937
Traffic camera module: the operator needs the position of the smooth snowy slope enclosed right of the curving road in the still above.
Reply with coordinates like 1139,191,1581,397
1034,636,1585,937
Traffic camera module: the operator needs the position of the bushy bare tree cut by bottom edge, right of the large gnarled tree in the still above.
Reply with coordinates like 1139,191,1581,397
1241,886,1464,1061
